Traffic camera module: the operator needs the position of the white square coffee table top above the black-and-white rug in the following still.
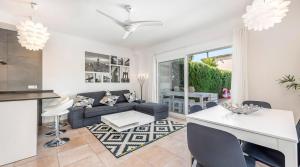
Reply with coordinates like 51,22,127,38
101,110,153,127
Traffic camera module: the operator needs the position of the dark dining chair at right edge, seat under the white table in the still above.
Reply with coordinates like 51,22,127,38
242,121,300,167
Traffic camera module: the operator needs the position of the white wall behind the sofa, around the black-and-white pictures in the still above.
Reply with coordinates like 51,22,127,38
43,32,137,95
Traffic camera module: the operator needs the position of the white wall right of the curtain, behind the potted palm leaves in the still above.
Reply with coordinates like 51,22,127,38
248,0,300,118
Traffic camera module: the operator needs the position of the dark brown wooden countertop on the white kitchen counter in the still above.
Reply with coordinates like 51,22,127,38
0,90,60,102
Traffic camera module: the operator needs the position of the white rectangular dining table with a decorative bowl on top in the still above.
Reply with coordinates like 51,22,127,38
186,105,298,167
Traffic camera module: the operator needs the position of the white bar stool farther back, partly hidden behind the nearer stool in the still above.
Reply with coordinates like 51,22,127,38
43,96,70,136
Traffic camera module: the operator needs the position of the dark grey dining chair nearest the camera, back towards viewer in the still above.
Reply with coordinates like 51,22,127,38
187,123,255,167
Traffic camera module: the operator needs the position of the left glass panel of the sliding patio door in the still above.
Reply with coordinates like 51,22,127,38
158,58,185,114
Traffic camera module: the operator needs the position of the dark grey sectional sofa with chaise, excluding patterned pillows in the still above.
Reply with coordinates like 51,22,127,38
68,90,168,128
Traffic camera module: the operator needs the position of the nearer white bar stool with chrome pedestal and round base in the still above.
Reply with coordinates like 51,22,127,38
42,99,73,148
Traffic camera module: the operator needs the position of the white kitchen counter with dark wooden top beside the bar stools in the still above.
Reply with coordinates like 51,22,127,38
0,90,59,166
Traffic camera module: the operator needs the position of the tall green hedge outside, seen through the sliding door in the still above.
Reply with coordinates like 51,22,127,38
189,61,231,96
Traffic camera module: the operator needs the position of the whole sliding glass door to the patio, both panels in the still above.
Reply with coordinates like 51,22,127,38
156,47,232,116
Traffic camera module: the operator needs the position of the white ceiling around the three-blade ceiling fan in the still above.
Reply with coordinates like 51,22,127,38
0,0,251,48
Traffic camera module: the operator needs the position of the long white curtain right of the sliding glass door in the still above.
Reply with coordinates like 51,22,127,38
231,27,248,104
